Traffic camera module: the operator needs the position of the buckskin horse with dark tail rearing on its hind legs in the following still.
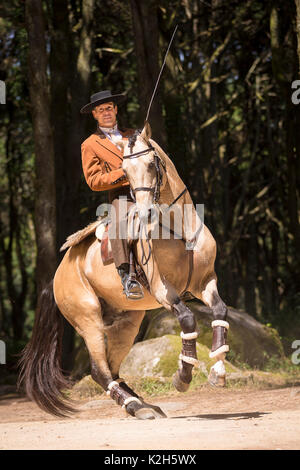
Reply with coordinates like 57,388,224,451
19,125,229,419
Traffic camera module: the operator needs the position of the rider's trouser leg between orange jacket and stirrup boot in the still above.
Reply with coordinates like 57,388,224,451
108,186,134,268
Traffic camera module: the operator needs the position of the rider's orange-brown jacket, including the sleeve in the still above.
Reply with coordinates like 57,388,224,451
81,129,134,191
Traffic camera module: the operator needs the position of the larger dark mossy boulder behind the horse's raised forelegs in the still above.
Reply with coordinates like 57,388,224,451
142,301,284,368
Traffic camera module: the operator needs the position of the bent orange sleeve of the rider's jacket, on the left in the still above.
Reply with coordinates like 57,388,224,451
81,143,128,191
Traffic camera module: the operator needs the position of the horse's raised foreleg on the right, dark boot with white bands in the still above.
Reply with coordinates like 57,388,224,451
201,278,229,386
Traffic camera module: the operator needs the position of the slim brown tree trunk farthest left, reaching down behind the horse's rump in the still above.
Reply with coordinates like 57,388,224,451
25,0,57,293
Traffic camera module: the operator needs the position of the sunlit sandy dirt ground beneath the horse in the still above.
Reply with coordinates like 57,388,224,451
0,387,300,452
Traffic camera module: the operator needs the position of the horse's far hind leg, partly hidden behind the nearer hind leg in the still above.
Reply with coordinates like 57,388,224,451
105,310,166,419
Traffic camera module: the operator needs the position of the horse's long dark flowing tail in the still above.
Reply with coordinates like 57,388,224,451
18,281,76,416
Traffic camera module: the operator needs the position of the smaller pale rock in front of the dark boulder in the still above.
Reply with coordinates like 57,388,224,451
120,335,237,379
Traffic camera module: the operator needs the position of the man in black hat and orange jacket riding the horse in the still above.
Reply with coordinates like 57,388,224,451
80,90,143,300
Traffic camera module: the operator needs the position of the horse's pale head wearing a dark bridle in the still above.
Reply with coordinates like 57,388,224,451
122,123,166,219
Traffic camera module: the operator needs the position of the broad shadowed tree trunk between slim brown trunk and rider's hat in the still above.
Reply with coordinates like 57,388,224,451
51,0,94,371
